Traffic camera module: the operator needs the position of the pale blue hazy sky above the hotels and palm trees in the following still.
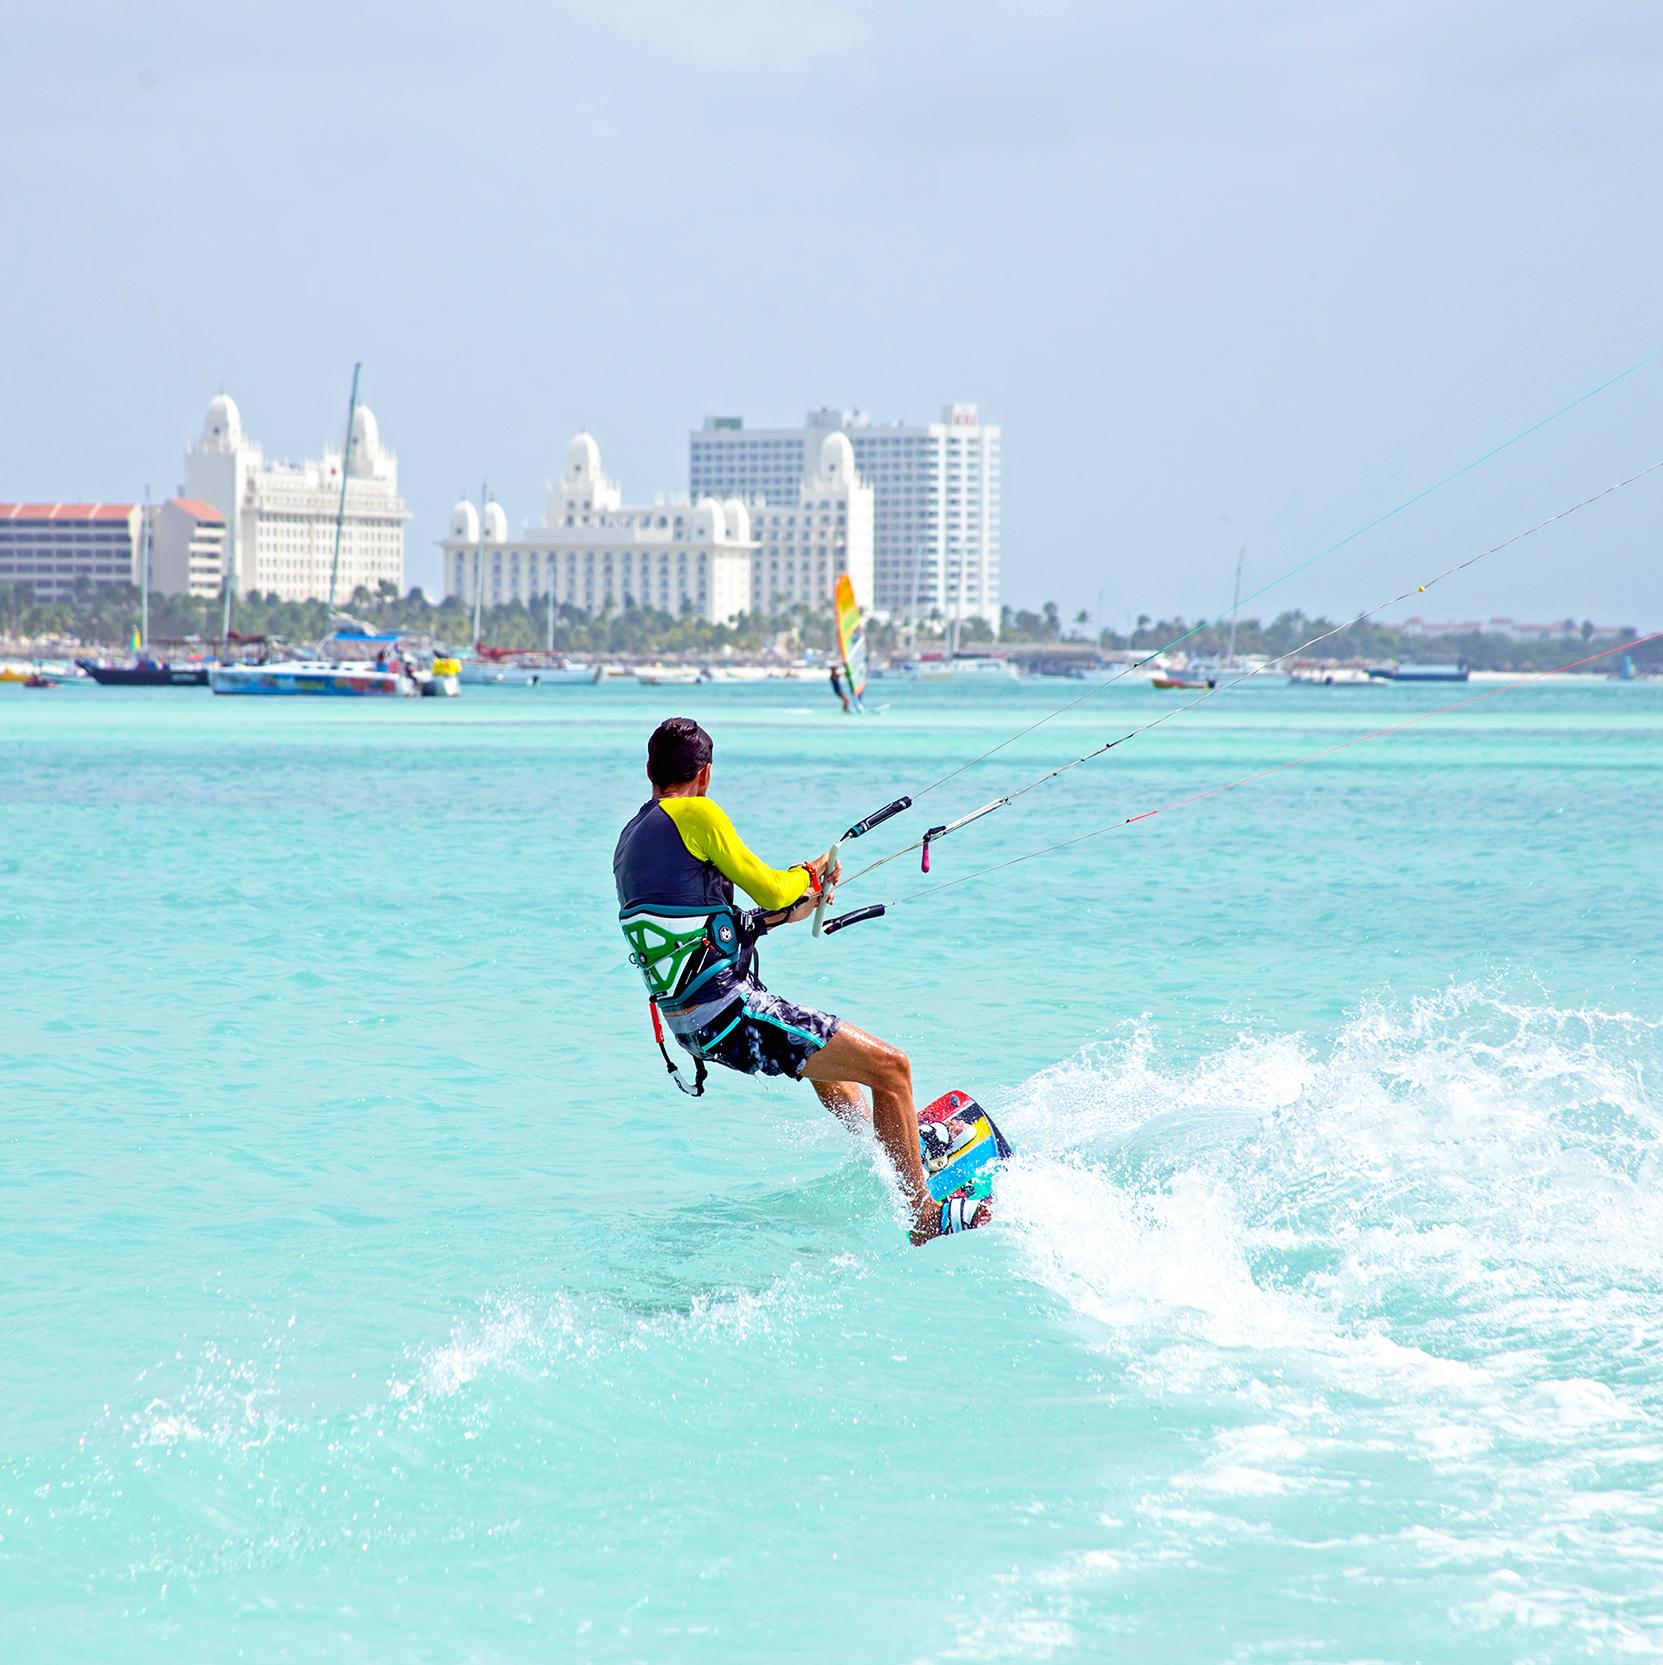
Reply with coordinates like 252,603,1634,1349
0,0,1663,628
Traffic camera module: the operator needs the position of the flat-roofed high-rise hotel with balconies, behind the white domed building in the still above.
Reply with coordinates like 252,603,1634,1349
688,405,1000,629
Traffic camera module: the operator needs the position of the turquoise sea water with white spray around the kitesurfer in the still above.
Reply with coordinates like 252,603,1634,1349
0,684,1663,1665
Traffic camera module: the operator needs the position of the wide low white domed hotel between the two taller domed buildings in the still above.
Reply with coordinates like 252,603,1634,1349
439,433,756,624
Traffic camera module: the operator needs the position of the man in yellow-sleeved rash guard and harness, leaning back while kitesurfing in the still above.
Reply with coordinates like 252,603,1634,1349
613,718,941,1242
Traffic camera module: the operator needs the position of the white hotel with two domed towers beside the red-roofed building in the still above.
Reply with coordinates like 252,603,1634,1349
181,393,410,604
